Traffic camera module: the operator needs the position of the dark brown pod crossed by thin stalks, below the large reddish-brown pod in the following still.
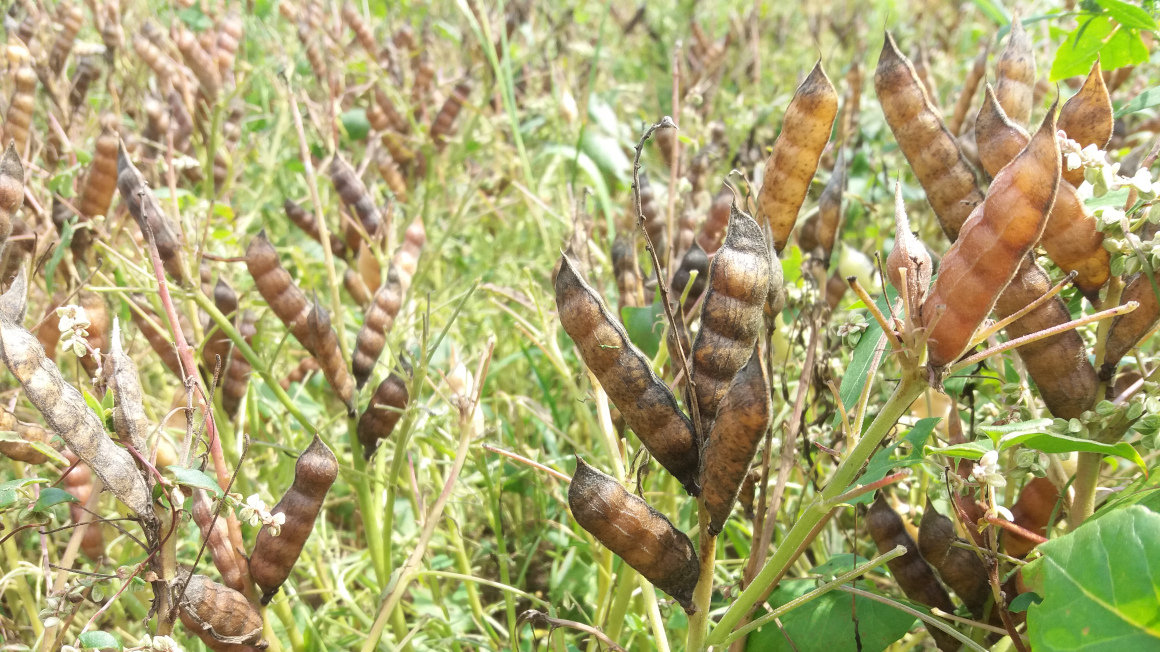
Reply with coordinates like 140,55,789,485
995,256,1097,419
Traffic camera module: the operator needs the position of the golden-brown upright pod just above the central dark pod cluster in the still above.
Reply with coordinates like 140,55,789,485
757,61,838,253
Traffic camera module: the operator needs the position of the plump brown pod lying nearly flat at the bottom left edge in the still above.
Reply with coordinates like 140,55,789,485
177,571,269,652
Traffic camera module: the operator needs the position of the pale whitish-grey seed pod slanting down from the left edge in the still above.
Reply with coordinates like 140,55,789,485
0,268,157,526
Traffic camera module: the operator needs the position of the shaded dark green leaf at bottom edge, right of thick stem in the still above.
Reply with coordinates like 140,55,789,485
746,580,914,652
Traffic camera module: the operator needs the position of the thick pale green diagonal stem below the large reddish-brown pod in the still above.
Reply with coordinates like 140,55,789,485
705,369,927,646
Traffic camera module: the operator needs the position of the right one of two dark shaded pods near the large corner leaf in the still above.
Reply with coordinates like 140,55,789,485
919,501,991,620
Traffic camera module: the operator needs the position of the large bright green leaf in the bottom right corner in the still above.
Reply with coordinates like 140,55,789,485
1023,505,1160,652
